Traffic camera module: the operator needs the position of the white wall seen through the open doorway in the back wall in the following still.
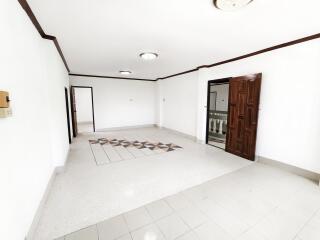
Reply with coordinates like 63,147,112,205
74,88,92,123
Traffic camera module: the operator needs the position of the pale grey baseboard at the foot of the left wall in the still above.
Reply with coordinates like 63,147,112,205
25,149,70,240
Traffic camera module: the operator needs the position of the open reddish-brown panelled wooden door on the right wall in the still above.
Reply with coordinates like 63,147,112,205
226,73,262,161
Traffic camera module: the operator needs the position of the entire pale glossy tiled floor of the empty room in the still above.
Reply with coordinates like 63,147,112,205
36,128,320,240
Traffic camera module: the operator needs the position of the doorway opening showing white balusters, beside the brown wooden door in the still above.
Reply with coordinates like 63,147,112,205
206,78,230,149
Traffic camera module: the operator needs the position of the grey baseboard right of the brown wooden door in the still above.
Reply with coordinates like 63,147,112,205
256,156,320,184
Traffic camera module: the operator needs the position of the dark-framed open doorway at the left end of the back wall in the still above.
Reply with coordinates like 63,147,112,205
70,86,95,137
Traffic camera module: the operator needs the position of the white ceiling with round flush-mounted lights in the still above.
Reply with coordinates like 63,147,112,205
28,0,320,79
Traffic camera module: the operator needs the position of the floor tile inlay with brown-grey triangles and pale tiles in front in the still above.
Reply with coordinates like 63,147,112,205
89,138,182,165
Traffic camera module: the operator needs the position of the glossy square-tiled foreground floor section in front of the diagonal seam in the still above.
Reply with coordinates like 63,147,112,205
53,163,320,240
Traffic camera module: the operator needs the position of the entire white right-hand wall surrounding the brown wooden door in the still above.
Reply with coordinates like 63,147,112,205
159,39,320,173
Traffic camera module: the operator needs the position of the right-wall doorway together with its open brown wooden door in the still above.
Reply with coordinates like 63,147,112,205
206,73,262,161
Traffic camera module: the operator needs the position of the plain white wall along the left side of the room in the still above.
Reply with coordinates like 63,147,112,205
0,0,69,240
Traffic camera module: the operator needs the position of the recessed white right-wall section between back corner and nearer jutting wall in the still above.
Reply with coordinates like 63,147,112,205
158,72,198,136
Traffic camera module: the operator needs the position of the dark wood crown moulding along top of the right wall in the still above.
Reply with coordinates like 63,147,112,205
157,33,320,80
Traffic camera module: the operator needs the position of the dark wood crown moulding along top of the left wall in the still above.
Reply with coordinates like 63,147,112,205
18,0,70,72
